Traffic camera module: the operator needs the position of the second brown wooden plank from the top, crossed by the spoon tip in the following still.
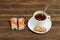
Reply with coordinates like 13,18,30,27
0,4,60,9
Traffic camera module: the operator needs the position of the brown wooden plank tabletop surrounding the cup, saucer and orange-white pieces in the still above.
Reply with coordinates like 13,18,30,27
0,0,60,40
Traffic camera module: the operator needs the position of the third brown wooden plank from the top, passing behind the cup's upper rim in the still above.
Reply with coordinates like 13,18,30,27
0,9,60,14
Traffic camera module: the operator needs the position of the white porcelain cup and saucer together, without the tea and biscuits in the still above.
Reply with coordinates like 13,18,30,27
28,11,52,34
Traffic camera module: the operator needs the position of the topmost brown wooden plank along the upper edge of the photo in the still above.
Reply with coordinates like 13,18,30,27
0,0,60,5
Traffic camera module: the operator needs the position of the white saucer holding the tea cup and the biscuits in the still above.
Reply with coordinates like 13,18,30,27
28,17,52,34
